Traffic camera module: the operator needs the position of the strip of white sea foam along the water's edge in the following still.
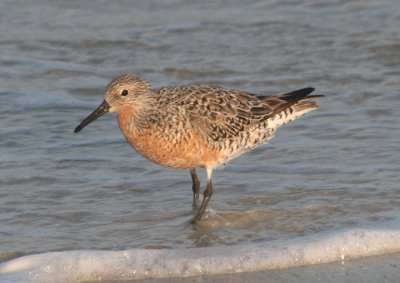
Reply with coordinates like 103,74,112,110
0,227,400,283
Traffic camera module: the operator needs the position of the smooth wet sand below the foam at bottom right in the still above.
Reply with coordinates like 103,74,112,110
107,253,400,283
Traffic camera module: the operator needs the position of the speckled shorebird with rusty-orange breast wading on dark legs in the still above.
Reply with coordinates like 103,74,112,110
74,74,322,223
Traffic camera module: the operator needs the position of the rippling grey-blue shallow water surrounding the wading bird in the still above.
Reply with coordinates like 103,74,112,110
0,0,400,282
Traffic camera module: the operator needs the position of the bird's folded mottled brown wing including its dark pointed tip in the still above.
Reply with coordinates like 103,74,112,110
156,85,313,142
